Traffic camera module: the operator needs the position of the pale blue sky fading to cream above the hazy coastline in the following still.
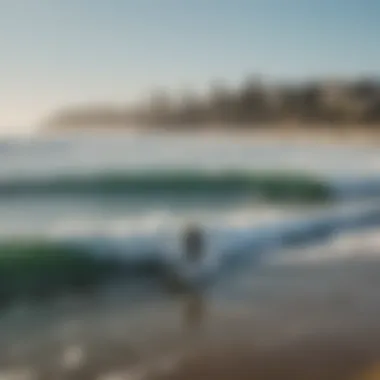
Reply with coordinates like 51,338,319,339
0,0,380,134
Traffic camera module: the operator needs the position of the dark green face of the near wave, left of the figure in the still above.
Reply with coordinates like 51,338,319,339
0,241,159,309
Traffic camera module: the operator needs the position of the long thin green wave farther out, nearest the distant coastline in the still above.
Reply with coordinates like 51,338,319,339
0,171,334,201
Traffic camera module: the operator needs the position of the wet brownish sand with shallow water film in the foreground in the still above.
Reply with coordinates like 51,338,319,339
0,248,380,380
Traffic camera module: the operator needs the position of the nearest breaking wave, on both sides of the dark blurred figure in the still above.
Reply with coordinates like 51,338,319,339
0,202,380,305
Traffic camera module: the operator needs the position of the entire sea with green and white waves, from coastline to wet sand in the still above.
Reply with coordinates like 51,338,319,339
0,133,380,378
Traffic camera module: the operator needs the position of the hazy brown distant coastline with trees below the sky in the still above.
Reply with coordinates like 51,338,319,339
40,77,380,140
